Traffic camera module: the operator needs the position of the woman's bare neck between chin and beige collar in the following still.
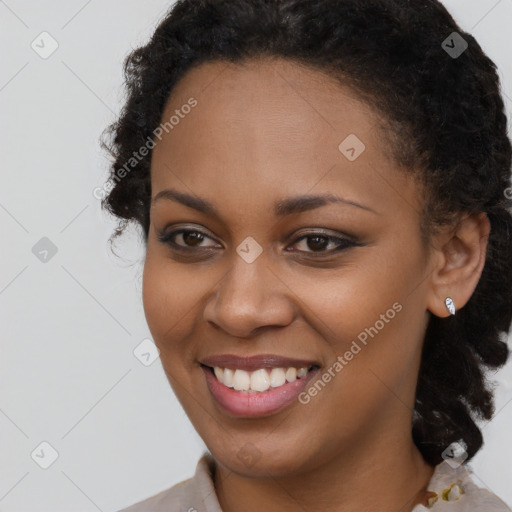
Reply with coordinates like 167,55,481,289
214,435,434,512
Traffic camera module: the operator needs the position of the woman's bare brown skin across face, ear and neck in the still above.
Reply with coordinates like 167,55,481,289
143,59,490,512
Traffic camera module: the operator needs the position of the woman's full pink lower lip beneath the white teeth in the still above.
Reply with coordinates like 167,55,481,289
201,366,319,418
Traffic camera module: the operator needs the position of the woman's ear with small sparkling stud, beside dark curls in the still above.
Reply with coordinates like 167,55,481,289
426,212,491,318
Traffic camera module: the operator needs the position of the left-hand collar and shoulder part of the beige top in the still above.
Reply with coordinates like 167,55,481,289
118,454,221,512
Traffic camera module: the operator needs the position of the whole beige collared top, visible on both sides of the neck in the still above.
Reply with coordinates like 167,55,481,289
118,453,512,512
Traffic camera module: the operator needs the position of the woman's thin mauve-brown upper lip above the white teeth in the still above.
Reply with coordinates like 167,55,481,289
199,354,320,371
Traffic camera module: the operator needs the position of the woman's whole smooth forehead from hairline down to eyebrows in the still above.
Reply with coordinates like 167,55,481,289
151,59,416,220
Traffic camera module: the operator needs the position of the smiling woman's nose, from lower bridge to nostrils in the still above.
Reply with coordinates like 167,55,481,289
204,250,296,338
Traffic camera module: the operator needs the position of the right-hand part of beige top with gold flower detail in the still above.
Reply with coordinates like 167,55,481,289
413,461,512,512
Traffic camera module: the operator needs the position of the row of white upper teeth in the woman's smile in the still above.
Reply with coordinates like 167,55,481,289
213,366,308,393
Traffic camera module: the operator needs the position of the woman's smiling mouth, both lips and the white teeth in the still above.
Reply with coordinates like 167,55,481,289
200,356,320,418
